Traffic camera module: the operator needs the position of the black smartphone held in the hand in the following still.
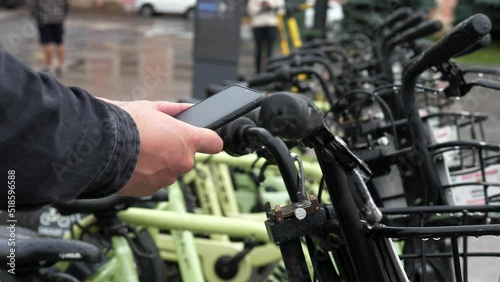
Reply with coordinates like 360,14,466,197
175,85,265,130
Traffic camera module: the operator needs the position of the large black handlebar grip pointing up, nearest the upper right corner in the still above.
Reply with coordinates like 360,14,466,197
420,14,491,67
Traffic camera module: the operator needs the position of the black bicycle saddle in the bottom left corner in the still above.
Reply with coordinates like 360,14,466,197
0,226,101,268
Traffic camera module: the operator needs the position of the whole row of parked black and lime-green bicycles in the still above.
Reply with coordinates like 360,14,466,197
0,8,500,282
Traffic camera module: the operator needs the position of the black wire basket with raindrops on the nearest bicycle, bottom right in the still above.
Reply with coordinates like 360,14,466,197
369,205,500,282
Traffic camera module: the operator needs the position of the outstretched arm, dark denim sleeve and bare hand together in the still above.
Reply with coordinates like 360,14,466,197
0,49,222,210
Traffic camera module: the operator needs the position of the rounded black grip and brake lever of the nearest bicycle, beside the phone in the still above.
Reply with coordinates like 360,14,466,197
260,92,382,225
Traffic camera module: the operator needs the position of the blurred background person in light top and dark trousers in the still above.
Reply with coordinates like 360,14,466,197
247,0,285,73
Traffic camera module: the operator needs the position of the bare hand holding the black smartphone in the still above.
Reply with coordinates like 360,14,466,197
102,99,223,197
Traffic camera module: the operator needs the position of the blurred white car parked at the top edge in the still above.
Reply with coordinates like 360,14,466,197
135,0,196,18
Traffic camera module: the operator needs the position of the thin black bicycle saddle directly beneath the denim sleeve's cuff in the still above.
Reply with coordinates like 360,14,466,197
53,190,168,215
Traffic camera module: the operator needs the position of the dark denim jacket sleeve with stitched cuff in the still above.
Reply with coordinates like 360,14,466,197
0,48,139,209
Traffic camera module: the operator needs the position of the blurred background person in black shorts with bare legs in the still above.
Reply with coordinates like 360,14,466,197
32,0,69,76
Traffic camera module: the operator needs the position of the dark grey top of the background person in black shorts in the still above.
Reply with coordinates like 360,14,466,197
33,0,69,25
